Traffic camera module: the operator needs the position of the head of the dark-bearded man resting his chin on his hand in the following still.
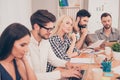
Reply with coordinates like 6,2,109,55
76,9,91,28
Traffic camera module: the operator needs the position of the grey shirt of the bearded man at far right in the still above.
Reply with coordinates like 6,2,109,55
95,28,120,41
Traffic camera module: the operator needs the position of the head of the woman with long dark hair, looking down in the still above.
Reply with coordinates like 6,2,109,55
0,23,30,60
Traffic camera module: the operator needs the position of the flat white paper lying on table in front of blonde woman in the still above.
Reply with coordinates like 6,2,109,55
70,58,95,64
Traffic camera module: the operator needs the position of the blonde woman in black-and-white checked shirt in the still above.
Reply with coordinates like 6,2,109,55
47,15,79,72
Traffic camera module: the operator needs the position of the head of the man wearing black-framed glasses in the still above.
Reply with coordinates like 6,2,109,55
30,10,56,39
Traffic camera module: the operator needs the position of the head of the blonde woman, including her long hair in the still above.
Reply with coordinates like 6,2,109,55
53,15,73,35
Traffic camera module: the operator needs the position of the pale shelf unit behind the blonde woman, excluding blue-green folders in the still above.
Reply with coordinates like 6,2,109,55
58,0,83,19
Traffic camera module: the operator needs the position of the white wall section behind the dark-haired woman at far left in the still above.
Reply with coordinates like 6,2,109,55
0,0,31,34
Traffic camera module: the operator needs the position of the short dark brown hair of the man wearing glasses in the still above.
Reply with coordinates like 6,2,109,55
30,10,56,29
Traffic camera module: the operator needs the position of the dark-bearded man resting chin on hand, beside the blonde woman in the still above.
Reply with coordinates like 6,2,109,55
73,9,91,49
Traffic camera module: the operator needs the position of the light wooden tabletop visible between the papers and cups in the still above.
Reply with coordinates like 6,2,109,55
76,44,120,80
